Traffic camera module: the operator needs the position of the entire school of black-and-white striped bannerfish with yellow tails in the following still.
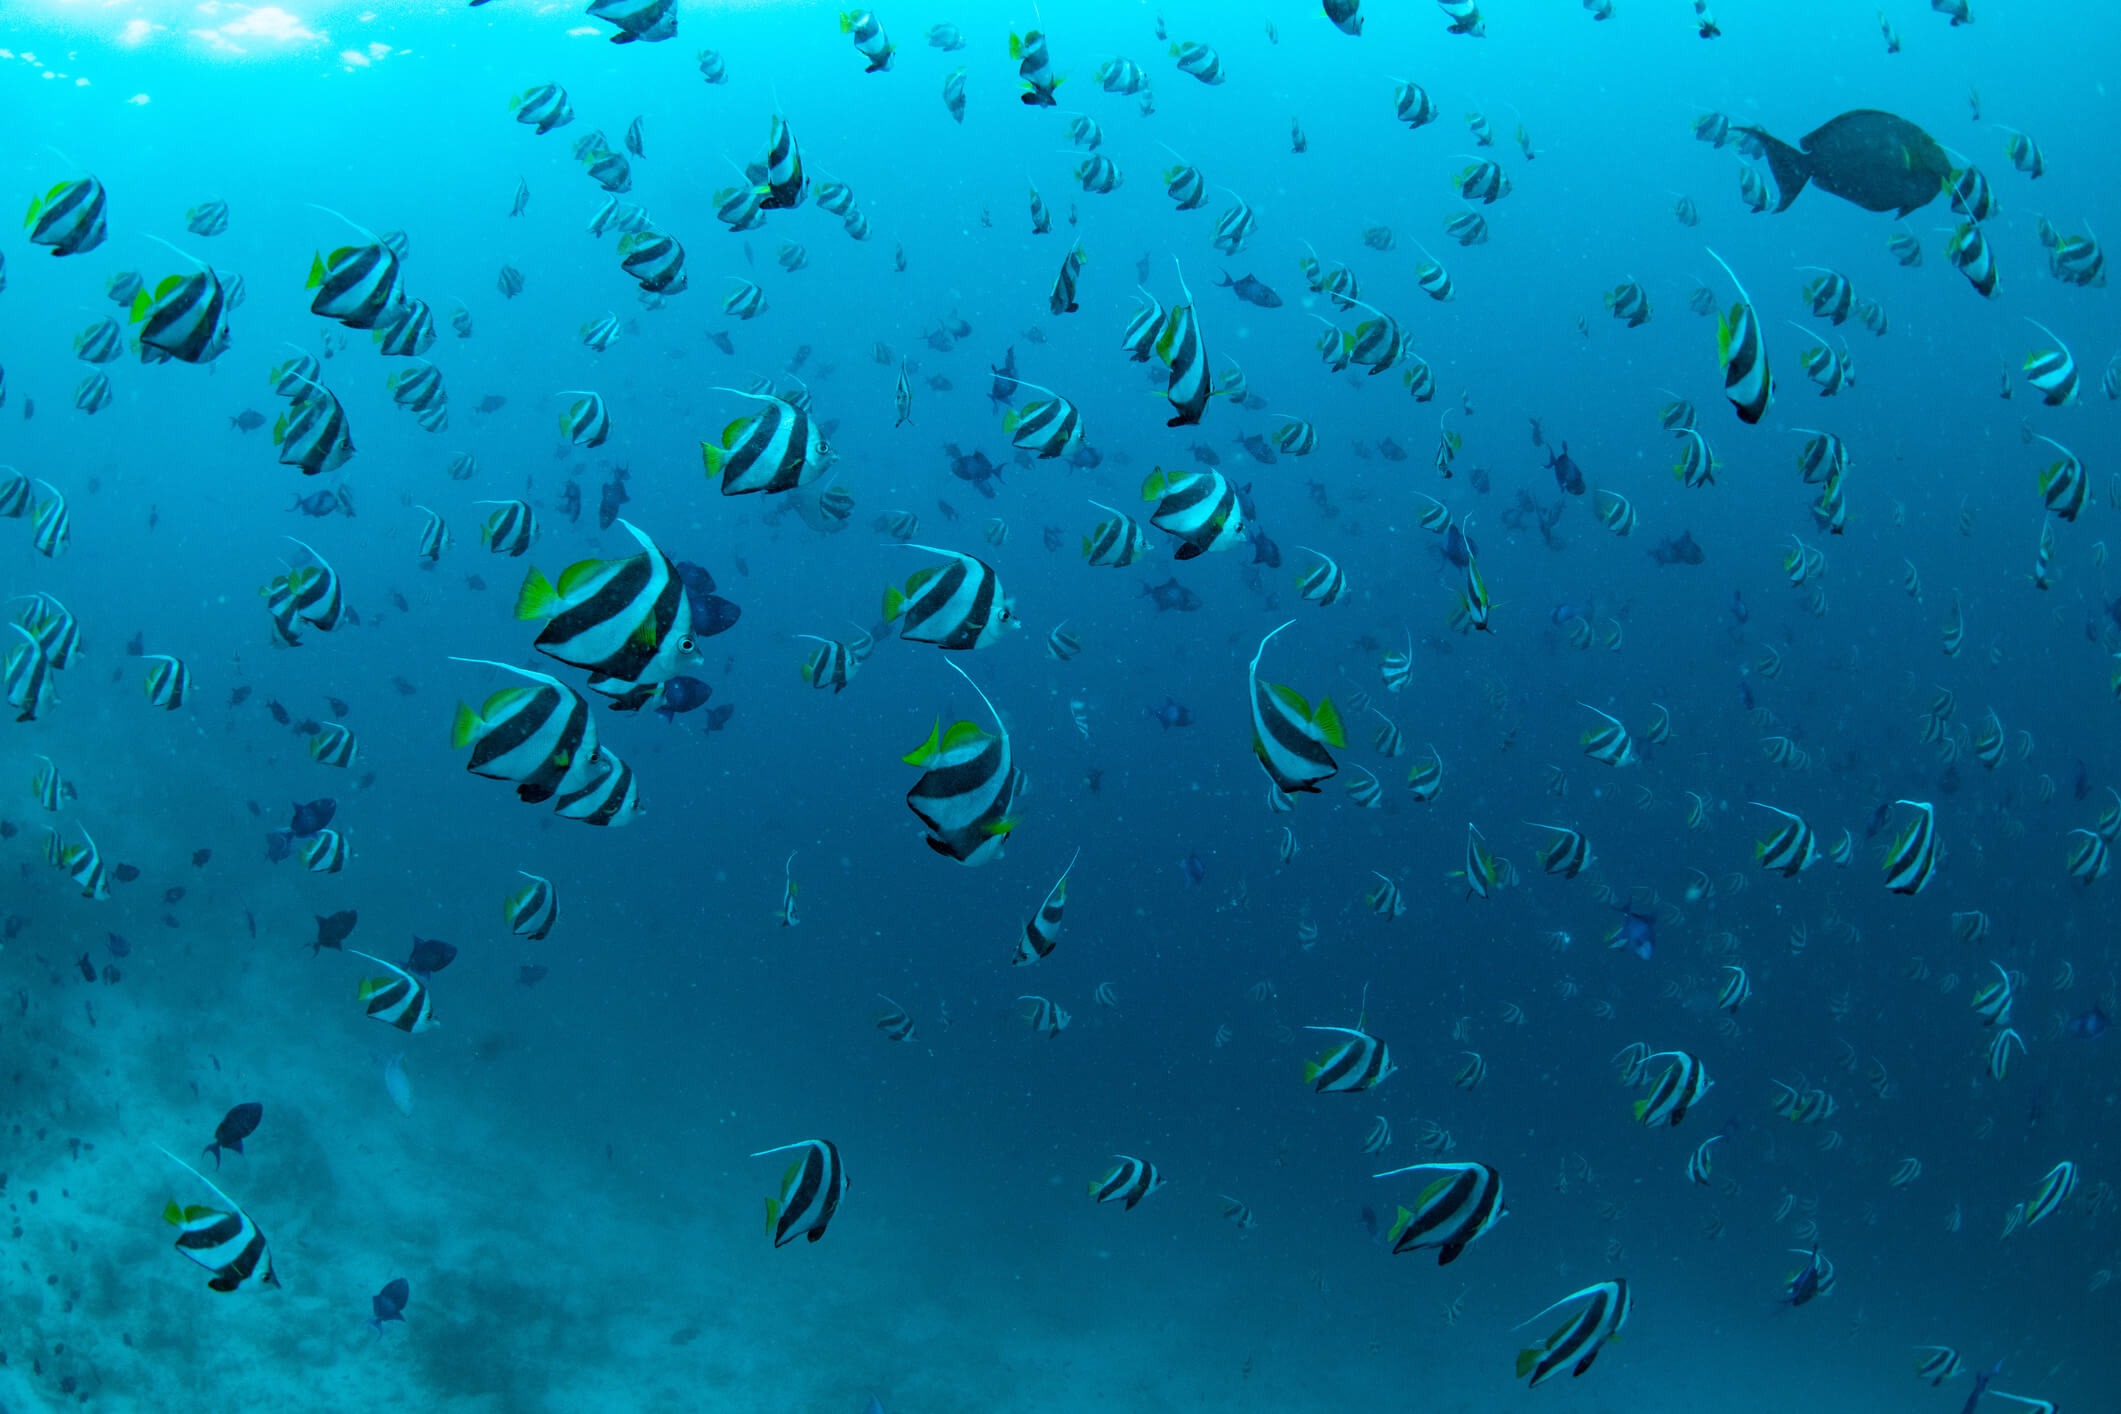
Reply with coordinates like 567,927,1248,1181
0,0,2121,1408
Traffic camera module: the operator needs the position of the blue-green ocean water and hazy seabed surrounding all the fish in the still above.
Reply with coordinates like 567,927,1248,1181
0,0,2121,1414
